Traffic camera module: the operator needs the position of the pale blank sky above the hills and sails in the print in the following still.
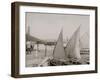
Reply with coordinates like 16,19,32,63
25,12,90,40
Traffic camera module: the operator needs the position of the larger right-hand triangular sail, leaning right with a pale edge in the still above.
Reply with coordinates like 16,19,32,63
65,27,81,61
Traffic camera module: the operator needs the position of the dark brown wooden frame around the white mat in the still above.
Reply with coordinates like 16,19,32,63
11,2,98,78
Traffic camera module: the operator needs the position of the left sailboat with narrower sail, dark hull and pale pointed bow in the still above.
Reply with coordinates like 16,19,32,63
39,30,66,66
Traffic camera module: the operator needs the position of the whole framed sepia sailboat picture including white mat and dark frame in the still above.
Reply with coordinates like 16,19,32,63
11,2,98,78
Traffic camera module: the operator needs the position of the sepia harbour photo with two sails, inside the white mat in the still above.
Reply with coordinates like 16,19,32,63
25,12,90,67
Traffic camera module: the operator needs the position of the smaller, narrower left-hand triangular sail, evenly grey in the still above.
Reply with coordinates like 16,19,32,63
53,30,66,60
